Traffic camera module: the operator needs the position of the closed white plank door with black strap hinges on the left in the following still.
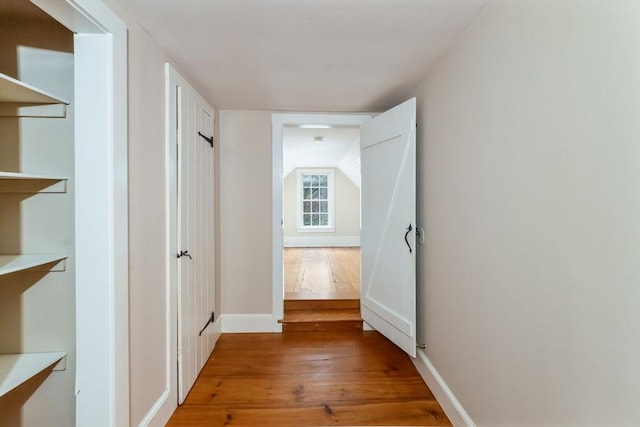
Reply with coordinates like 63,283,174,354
175,72,217,403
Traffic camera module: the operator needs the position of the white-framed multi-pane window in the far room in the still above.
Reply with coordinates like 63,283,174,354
297,169,335,232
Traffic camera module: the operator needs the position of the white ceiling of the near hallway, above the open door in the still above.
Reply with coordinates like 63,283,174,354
116,0,483,112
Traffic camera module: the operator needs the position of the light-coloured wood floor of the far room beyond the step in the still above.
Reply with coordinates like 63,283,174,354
284,248,360,299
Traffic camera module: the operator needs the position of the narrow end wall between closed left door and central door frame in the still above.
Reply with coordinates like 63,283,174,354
218,110,272,314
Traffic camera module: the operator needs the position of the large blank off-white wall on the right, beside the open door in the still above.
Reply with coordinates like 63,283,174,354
416,1,640,426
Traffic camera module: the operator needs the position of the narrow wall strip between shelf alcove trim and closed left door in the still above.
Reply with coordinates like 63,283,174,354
101,0,219,425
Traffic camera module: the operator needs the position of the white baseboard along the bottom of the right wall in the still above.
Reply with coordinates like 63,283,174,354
412,349,476,427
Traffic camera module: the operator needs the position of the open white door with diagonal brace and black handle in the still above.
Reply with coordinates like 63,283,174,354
360,98,416,357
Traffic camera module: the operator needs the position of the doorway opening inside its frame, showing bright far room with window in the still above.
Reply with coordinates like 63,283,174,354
282,123,360,300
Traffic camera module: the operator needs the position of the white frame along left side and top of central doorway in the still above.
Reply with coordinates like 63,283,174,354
271,113,374,332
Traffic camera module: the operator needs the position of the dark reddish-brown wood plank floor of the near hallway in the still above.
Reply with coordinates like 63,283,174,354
167,332,451,427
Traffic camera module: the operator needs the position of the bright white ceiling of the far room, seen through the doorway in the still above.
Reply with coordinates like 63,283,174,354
282,127,360,187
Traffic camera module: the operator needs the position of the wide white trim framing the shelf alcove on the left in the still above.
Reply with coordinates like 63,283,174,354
32,0,129,427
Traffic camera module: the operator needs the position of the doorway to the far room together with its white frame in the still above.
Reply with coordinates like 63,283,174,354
272,114,371,331
